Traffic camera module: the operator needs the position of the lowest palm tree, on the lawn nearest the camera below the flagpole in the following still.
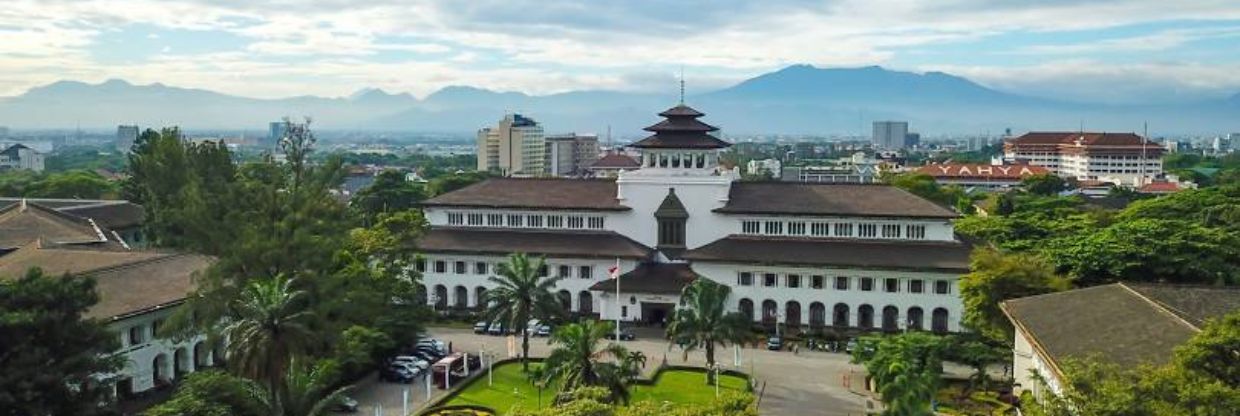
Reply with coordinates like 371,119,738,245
543,319,630,401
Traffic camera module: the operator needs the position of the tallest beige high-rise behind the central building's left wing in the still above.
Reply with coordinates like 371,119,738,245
477,114,545,176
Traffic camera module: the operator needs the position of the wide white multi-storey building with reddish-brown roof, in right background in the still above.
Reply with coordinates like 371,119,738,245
1003,132,1166,188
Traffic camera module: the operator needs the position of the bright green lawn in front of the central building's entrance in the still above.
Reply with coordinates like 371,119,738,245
444,363,745,414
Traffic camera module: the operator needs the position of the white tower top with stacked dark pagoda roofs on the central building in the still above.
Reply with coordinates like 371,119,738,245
629,104,732,174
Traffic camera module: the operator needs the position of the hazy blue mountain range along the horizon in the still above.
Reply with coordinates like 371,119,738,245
0,65,1240,138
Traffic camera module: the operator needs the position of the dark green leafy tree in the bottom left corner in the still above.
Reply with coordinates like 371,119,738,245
0,268,120,415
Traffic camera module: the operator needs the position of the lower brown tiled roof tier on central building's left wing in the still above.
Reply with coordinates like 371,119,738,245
418,227,651,258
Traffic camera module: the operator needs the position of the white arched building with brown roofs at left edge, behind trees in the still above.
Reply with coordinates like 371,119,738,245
0,199,223,399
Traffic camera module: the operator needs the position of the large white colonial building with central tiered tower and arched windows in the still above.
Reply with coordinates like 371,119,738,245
418,104,970,332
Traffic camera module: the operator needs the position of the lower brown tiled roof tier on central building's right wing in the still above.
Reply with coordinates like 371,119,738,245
681,236,972,272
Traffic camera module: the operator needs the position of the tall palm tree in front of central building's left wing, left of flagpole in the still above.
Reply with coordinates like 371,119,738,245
486,253,564,371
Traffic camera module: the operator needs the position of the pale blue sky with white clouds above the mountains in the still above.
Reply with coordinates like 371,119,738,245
0,0,1240,102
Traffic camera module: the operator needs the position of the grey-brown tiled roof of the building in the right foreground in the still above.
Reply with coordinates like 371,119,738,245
1001,283,1240,366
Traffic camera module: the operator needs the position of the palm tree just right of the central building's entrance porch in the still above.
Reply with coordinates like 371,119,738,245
667,278,749,382
